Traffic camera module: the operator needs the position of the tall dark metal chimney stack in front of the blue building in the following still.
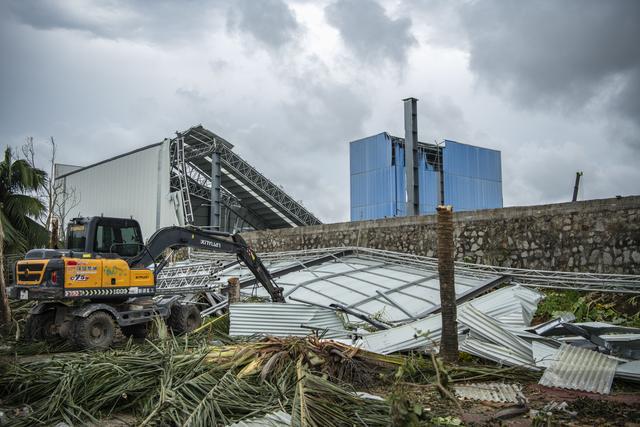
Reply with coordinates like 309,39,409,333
402,98,420,216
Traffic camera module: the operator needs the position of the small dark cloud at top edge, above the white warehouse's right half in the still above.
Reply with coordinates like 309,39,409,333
227,0,300,49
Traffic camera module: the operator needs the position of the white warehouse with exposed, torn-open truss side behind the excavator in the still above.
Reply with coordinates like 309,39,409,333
55,125,321,239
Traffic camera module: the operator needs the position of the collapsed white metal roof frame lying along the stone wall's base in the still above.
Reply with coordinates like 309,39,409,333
158,247,640,323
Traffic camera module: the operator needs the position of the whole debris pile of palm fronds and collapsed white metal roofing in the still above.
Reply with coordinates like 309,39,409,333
0,250,640,426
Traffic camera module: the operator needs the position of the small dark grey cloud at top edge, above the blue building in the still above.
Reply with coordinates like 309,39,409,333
325,0,416,64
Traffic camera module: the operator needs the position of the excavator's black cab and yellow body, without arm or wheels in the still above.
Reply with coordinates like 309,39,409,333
13,216,155,301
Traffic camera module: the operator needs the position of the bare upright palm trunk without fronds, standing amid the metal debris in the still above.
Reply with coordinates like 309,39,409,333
436,206,458,363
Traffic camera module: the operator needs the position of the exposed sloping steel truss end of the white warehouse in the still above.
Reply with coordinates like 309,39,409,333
170,126,321,231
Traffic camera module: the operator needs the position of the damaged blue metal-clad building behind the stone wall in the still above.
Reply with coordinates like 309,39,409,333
350,132,502,221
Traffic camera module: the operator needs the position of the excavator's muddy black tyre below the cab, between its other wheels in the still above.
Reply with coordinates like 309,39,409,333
71,311,116,350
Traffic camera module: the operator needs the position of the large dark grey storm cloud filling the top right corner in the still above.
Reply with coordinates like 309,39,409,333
460,0,640,125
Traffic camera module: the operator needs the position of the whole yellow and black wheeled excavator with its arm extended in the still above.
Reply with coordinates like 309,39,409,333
9,216,284,349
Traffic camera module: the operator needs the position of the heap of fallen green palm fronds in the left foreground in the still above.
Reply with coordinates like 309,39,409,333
0,338,396,426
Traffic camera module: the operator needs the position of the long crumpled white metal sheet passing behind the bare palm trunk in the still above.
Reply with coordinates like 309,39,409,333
356,286,542,354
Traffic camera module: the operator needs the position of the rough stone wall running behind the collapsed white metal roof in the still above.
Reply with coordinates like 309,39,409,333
244,196,640,274
